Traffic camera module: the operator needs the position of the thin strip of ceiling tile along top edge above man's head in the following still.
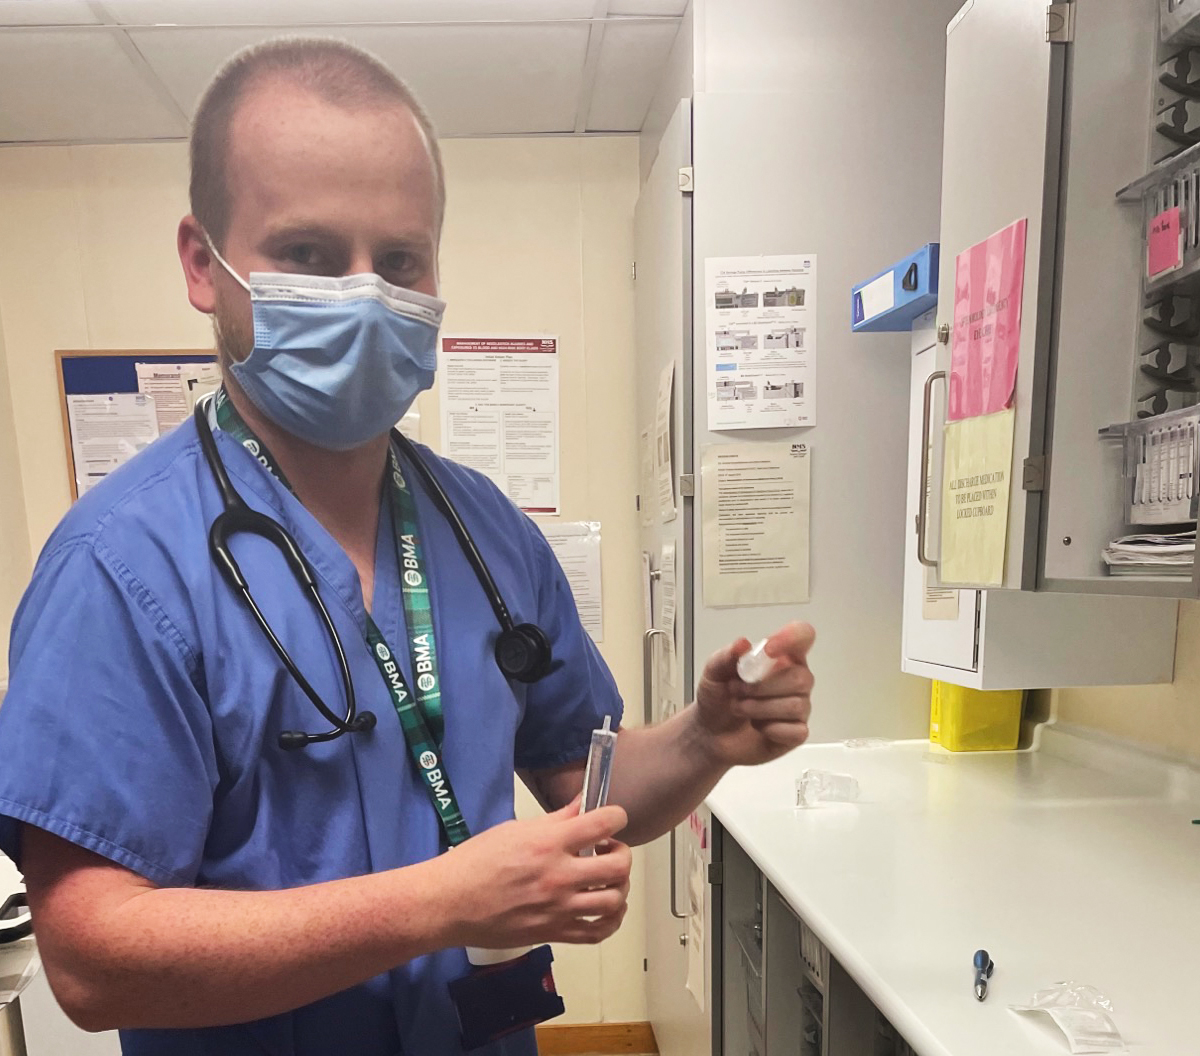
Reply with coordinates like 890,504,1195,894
104,0,595,25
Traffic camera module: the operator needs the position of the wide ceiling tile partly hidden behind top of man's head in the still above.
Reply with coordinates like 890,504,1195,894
130,24,588,136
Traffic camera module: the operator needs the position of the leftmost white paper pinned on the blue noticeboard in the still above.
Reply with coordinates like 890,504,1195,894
67,393,160,496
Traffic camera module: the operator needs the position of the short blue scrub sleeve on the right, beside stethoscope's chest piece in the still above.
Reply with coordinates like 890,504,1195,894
516,522,624,770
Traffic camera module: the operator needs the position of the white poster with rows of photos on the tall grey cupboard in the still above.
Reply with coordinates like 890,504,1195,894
704,253,817,430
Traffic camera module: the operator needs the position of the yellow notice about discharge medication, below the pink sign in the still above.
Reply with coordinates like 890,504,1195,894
941,408,1014,587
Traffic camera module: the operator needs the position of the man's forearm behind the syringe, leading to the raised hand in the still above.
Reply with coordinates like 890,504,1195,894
608,704,728,844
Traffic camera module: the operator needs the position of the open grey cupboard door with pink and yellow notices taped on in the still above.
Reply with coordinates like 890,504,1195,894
937,0,1069,589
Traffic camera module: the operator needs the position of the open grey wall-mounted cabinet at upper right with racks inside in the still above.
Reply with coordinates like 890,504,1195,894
930,0,1200,597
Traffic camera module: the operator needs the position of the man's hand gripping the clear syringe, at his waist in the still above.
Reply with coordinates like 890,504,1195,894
437,800,632,949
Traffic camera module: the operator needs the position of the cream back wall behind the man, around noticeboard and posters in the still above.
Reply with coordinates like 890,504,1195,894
0,137,646,1021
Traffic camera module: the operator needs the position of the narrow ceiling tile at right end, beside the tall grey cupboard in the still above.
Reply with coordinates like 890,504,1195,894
587,22,679,132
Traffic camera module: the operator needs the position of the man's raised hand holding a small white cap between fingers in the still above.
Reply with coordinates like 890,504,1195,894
696,623,816,766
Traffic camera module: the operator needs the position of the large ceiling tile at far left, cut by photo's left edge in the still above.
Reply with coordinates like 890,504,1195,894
0,29,187,143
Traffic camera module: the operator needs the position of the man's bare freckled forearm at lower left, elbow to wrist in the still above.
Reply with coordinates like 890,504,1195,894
34,836,454,1031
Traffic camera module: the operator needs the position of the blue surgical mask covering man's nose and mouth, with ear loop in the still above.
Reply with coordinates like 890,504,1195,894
209,242,445,451
